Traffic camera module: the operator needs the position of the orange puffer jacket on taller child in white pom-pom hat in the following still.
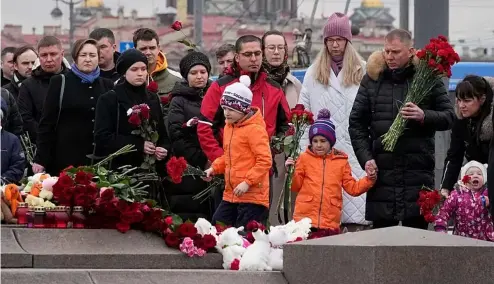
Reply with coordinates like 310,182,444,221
212,108,273,207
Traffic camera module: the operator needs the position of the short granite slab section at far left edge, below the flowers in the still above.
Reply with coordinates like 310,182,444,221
1,228,33,268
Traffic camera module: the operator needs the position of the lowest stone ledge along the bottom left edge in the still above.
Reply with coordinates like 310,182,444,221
1,269,288,284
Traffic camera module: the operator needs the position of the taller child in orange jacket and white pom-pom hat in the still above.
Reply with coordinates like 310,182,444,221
205,75,272,227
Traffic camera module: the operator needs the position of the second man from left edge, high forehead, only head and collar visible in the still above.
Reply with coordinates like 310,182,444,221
4,45,38,100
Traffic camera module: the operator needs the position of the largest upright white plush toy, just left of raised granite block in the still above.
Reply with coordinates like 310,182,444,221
239,229,272,271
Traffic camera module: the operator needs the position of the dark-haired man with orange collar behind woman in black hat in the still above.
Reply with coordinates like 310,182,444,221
132,28,182,97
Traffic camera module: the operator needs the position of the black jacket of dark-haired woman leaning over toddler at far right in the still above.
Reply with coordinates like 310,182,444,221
442,109,493,190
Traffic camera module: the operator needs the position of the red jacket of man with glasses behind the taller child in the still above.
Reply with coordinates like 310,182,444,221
197,72,290,162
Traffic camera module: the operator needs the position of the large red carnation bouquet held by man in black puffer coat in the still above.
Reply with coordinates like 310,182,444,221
382,36,460,152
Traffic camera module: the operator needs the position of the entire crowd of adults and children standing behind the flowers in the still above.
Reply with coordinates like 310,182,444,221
1,13,494,241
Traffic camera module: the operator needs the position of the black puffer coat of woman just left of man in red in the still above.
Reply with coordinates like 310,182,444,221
167,81,211,221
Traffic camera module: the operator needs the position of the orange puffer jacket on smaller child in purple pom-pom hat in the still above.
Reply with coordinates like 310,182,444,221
292,148,374,229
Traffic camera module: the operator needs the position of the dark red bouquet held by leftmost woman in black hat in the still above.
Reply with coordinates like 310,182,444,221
127,104,159,172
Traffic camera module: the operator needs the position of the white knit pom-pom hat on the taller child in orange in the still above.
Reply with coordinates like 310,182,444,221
220,75,252,113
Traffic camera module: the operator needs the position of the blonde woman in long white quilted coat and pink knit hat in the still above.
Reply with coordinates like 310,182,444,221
299,13,370,231
